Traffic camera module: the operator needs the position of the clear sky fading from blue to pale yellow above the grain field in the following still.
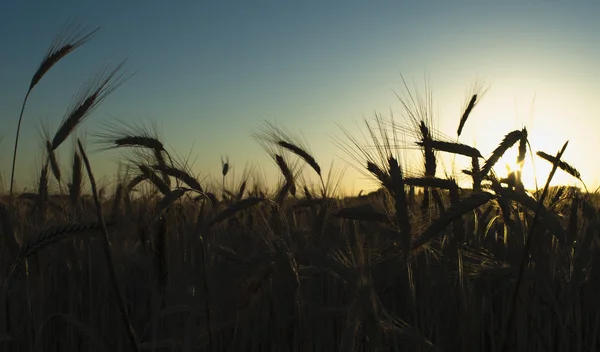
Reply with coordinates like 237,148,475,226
0,0,600,193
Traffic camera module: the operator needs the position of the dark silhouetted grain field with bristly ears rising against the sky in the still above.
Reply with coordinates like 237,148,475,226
0,21,600,351
